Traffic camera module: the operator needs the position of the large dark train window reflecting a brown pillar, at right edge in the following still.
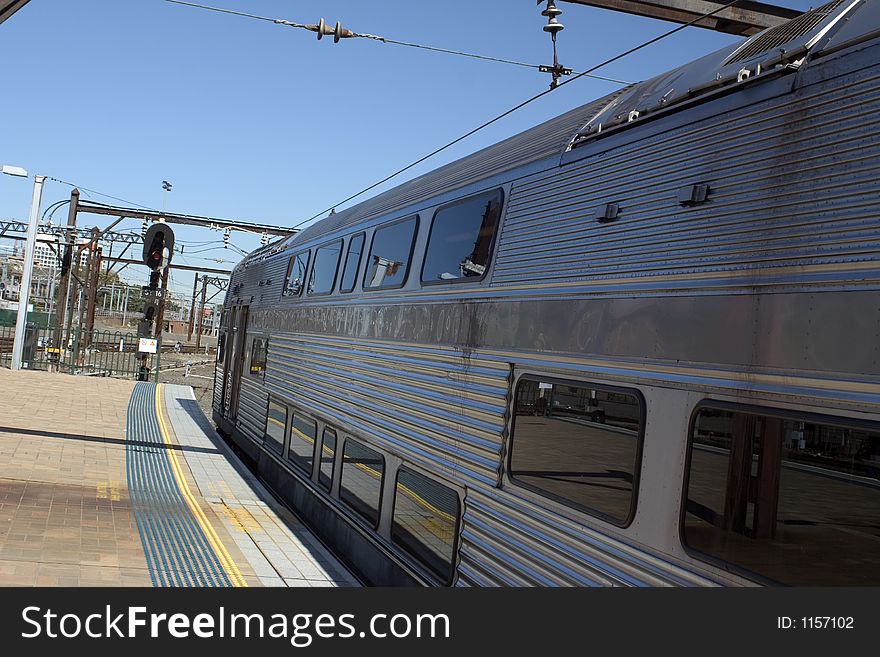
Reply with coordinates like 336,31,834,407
682,405,880,586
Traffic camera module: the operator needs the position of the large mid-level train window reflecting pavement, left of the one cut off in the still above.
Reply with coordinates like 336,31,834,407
509,379,644,527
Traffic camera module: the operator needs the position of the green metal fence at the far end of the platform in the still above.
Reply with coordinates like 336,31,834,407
0,326,162,380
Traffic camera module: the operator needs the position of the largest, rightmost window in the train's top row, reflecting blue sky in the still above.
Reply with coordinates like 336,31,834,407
422,189,501,283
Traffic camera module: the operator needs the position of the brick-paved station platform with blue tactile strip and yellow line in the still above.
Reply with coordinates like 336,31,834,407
0,369,358,587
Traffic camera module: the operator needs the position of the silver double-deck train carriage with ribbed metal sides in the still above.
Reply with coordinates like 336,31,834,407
213,0,880,586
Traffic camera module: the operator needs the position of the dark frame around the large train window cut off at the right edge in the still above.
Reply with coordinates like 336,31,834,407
678,398,880,586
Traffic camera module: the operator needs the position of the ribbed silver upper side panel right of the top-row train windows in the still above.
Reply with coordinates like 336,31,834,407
492,62,880,288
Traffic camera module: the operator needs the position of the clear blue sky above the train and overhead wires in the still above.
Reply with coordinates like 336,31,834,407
0,0,810,291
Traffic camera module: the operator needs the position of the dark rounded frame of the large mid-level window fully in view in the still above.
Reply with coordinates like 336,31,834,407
504,371,648,529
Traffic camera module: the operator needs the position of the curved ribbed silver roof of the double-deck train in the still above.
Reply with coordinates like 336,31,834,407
246,0,868,260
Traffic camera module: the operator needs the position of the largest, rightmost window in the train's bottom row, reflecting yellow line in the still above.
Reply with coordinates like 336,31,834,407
391,466,461,582
